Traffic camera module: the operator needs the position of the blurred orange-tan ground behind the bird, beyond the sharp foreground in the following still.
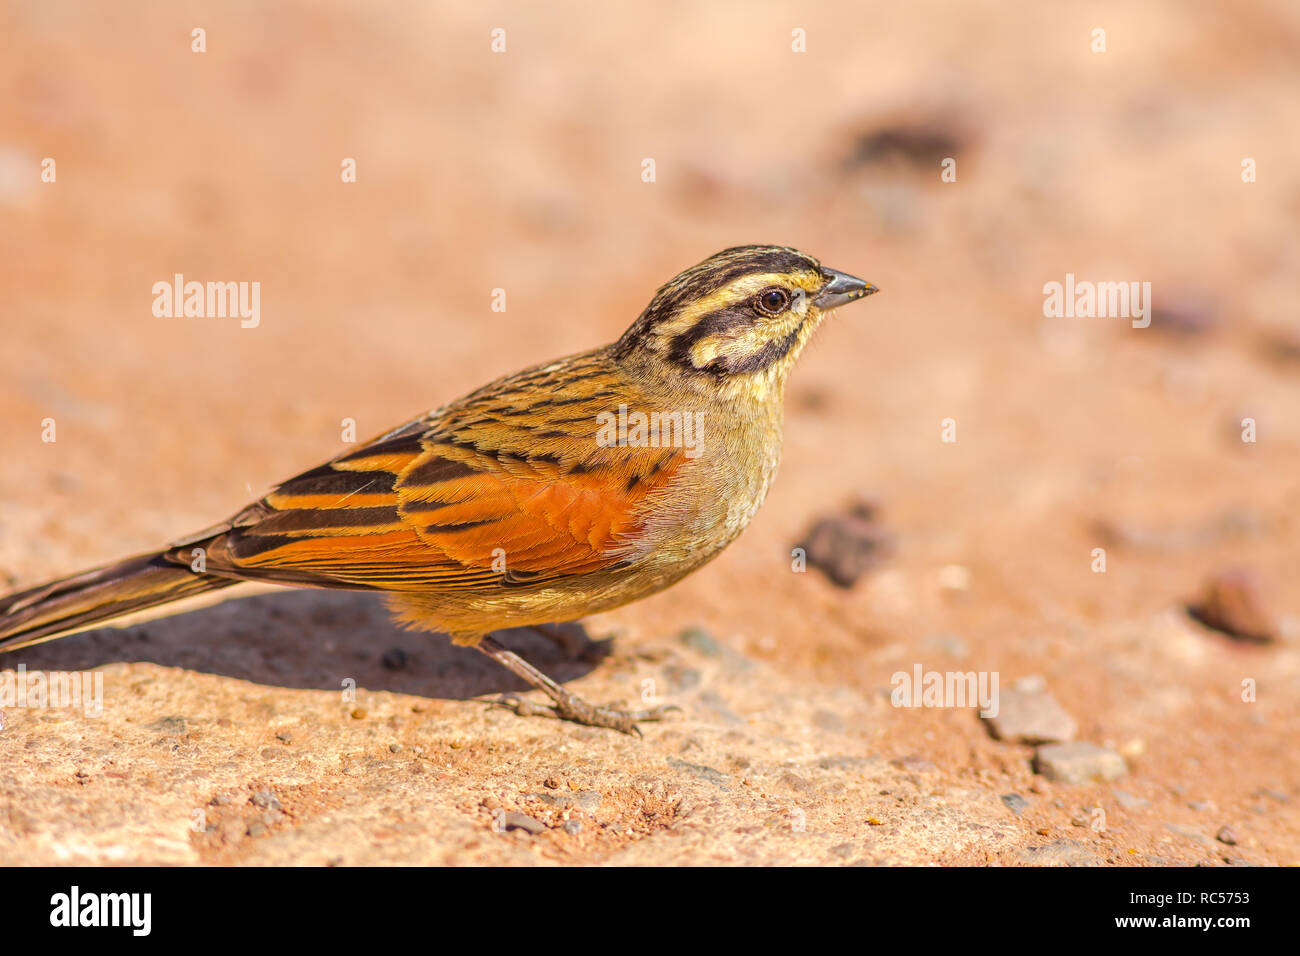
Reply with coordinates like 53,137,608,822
0,0,1300,862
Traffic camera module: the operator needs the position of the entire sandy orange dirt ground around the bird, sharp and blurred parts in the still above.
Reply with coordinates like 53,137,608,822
0,0,1300,866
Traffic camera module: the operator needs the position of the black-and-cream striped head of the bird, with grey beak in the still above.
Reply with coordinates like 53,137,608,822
614,246,876,390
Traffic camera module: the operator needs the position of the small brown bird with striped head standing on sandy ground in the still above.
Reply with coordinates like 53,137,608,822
0,246,876,734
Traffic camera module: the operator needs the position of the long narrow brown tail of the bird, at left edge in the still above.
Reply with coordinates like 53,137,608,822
0,551,239,652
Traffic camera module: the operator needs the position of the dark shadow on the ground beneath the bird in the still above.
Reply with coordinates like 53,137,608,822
0,591,607,700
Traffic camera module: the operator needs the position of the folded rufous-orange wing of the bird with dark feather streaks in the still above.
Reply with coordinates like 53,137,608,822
170,364,685,592
